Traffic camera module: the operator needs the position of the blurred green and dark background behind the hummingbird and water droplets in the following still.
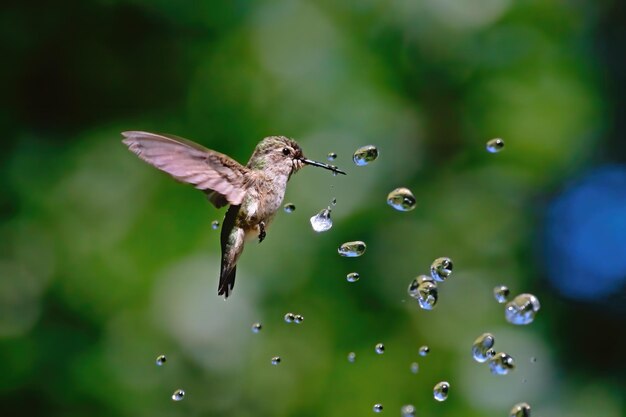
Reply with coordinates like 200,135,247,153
0,0,626,417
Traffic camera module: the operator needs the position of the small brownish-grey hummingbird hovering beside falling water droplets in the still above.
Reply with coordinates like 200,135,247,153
122,131,346,298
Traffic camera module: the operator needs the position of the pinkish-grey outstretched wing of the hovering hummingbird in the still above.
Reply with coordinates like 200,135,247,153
122,131,248,208
